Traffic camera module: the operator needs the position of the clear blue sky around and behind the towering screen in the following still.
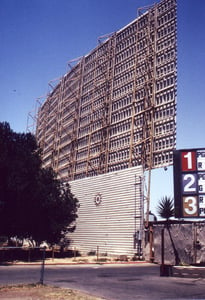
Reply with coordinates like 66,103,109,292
0,0,205,216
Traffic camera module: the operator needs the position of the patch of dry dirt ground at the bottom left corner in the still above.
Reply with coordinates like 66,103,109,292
0,284,102,300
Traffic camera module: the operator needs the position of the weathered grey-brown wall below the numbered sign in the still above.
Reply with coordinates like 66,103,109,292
153,223,205,265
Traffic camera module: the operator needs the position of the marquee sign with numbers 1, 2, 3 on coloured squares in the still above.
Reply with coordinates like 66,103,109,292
173,148,205,218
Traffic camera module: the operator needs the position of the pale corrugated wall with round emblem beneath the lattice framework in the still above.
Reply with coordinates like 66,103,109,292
69,167,143,255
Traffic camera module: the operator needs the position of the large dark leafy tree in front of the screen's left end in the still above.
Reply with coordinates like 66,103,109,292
0,123,78,243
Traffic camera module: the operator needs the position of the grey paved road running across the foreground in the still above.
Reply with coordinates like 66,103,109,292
0,263,205,300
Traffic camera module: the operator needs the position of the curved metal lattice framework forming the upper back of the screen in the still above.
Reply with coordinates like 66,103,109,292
36,0,177,180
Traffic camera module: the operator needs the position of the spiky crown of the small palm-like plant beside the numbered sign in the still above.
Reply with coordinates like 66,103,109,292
157,196,174,220
